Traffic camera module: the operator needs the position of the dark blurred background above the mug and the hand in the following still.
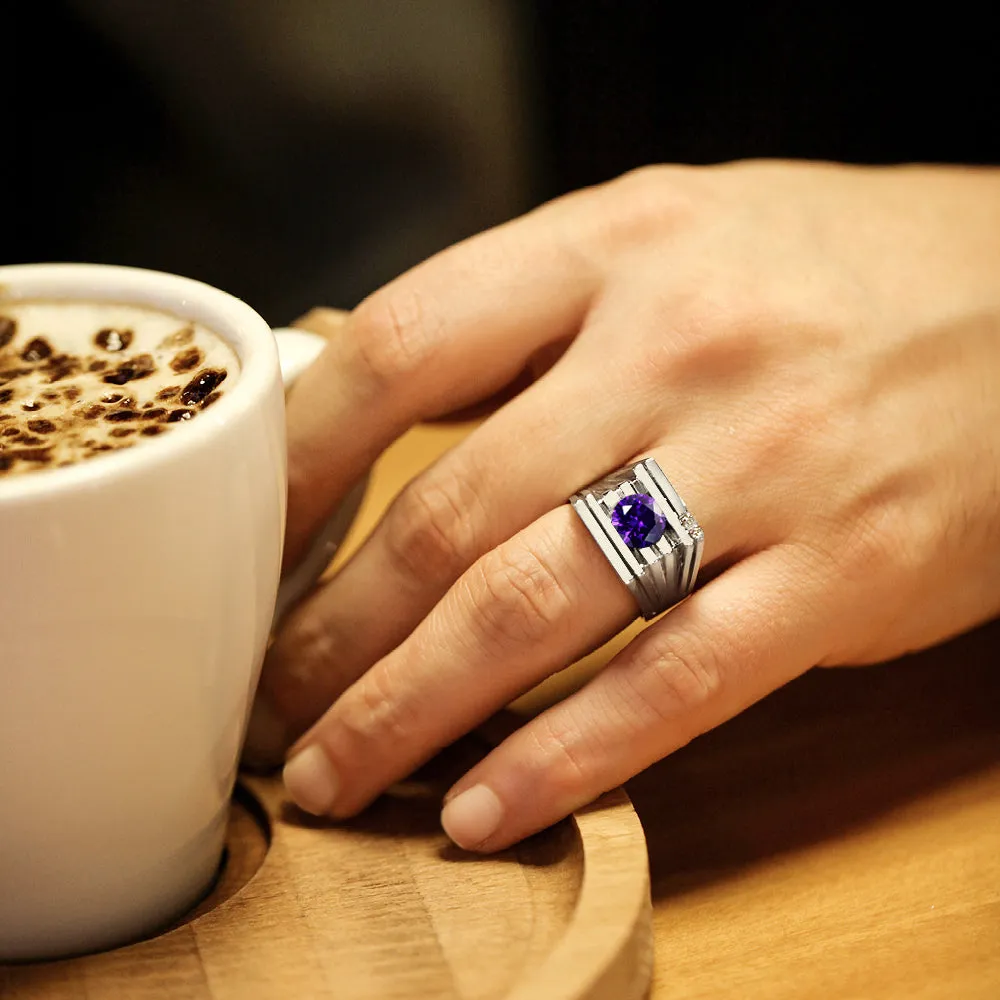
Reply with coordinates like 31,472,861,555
7,0,1000,323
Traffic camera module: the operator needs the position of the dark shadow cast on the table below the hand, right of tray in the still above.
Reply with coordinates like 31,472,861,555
628,622,1000,899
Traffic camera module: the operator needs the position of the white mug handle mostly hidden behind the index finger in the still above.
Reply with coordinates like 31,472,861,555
271,327,368,630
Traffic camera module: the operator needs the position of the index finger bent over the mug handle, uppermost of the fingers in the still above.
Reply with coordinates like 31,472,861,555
286,209,597,564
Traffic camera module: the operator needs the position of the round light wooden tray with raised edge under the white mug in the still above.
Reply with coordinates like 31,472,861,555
0,734,652,1000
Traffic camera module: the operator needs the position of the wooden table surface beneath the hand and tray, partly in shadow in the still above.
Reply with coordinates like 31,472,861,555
356,427,1000,1000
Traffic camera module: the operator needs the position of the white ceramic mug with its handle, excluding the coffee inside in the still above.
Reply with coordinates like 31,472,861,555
0,264,360,960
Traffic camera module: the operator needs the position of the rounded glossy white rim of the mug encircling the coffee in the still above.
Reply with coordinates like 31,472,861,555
0,262,280,507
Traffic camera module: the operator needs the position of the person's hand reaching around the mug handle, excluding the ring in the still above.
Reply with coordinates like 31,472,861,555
251,163,1000,851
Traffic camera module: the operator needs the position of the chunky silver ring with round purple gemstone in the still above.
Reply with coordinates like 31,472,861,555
569,458,705,621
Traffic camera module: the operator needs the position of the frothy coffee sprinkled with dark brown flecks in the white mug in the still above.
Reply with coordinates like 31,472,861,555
0,300,239,476
